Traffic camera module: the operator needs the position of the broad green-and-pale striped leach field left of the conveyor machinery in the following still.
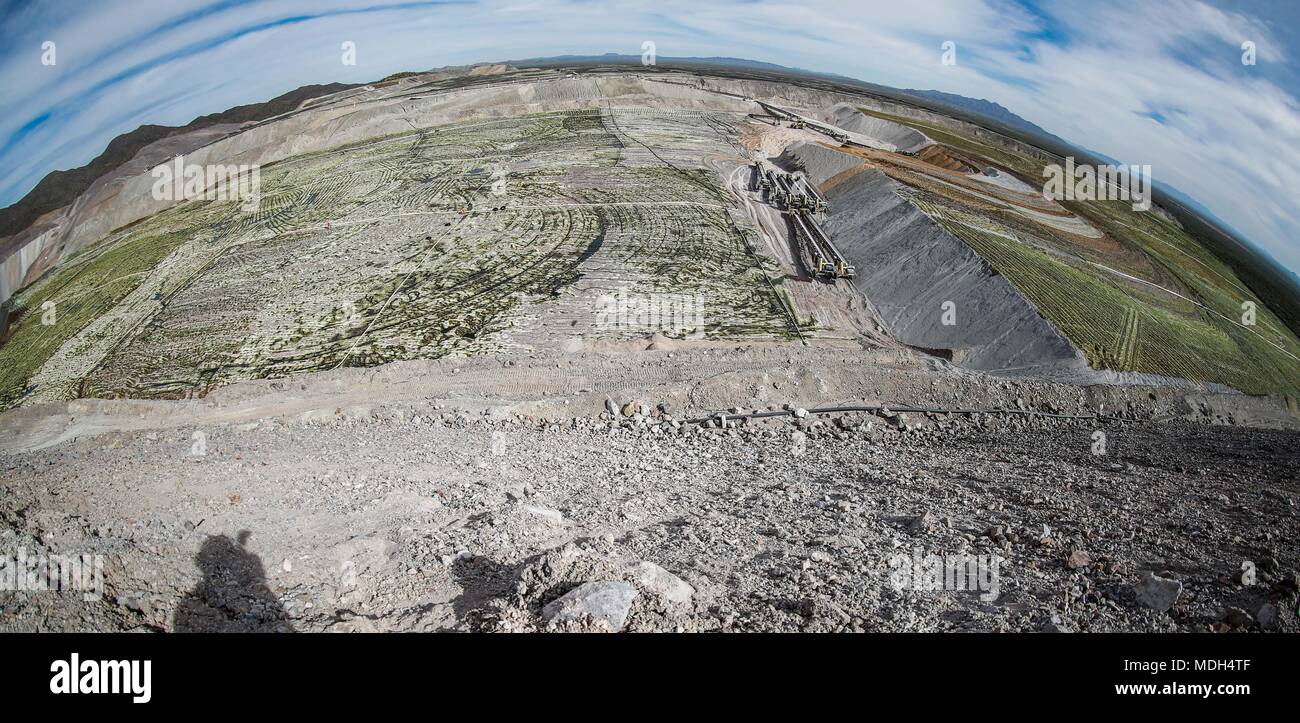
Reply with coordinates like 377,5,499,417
0,108,798,407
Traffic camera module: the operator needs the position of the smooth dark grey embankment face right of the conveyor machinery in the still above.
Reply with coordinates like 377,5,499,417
783,138,1091,376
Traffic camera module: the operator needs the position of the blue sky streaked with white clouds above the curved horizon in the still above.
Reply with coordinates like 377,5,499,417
0,0,1300,270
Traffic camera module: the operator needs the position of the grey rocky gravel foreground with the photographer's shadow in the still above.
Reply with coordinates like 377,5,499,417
0,402,1300,632
